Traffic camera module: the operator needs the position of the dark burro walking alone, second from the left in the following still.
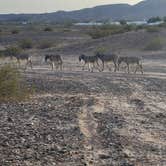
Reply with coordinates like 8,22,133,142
45,54,63,70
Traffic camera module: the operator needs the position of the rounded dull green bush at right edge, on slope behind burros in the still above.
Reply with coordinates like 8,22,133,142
144,38,166,51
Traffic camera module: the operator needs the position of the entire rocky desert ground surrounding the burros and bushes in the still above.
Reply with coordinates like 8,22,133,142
0,25,166,166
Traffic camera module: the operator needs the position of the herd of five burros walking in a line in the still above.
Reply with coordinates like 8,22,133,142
4,52,143,74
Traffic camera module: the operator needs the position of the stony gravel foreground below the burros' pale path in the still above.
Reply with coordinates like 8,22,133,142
0,70,166,166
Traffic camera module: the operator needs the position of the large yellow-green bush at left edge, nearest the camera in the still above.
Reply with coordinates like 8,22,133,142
0,65,33,102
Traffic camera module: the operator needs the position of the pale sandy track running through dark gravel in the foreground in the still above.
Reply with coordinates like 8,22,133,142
78,98,111,166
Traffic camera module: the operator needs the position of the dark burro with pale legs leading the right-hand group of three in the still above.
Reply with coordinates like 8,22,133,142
79,54,100,72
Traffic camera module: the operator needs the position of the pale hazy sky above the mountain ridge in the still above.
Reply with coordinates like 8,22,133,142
0,0,141,14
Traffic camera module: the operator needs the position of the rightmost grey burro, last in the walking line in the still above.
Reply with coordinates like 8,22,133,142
118,56,143,74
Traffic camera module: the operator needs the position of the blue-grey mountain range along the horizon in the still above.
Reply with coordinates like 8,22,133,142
0,0,166,22
